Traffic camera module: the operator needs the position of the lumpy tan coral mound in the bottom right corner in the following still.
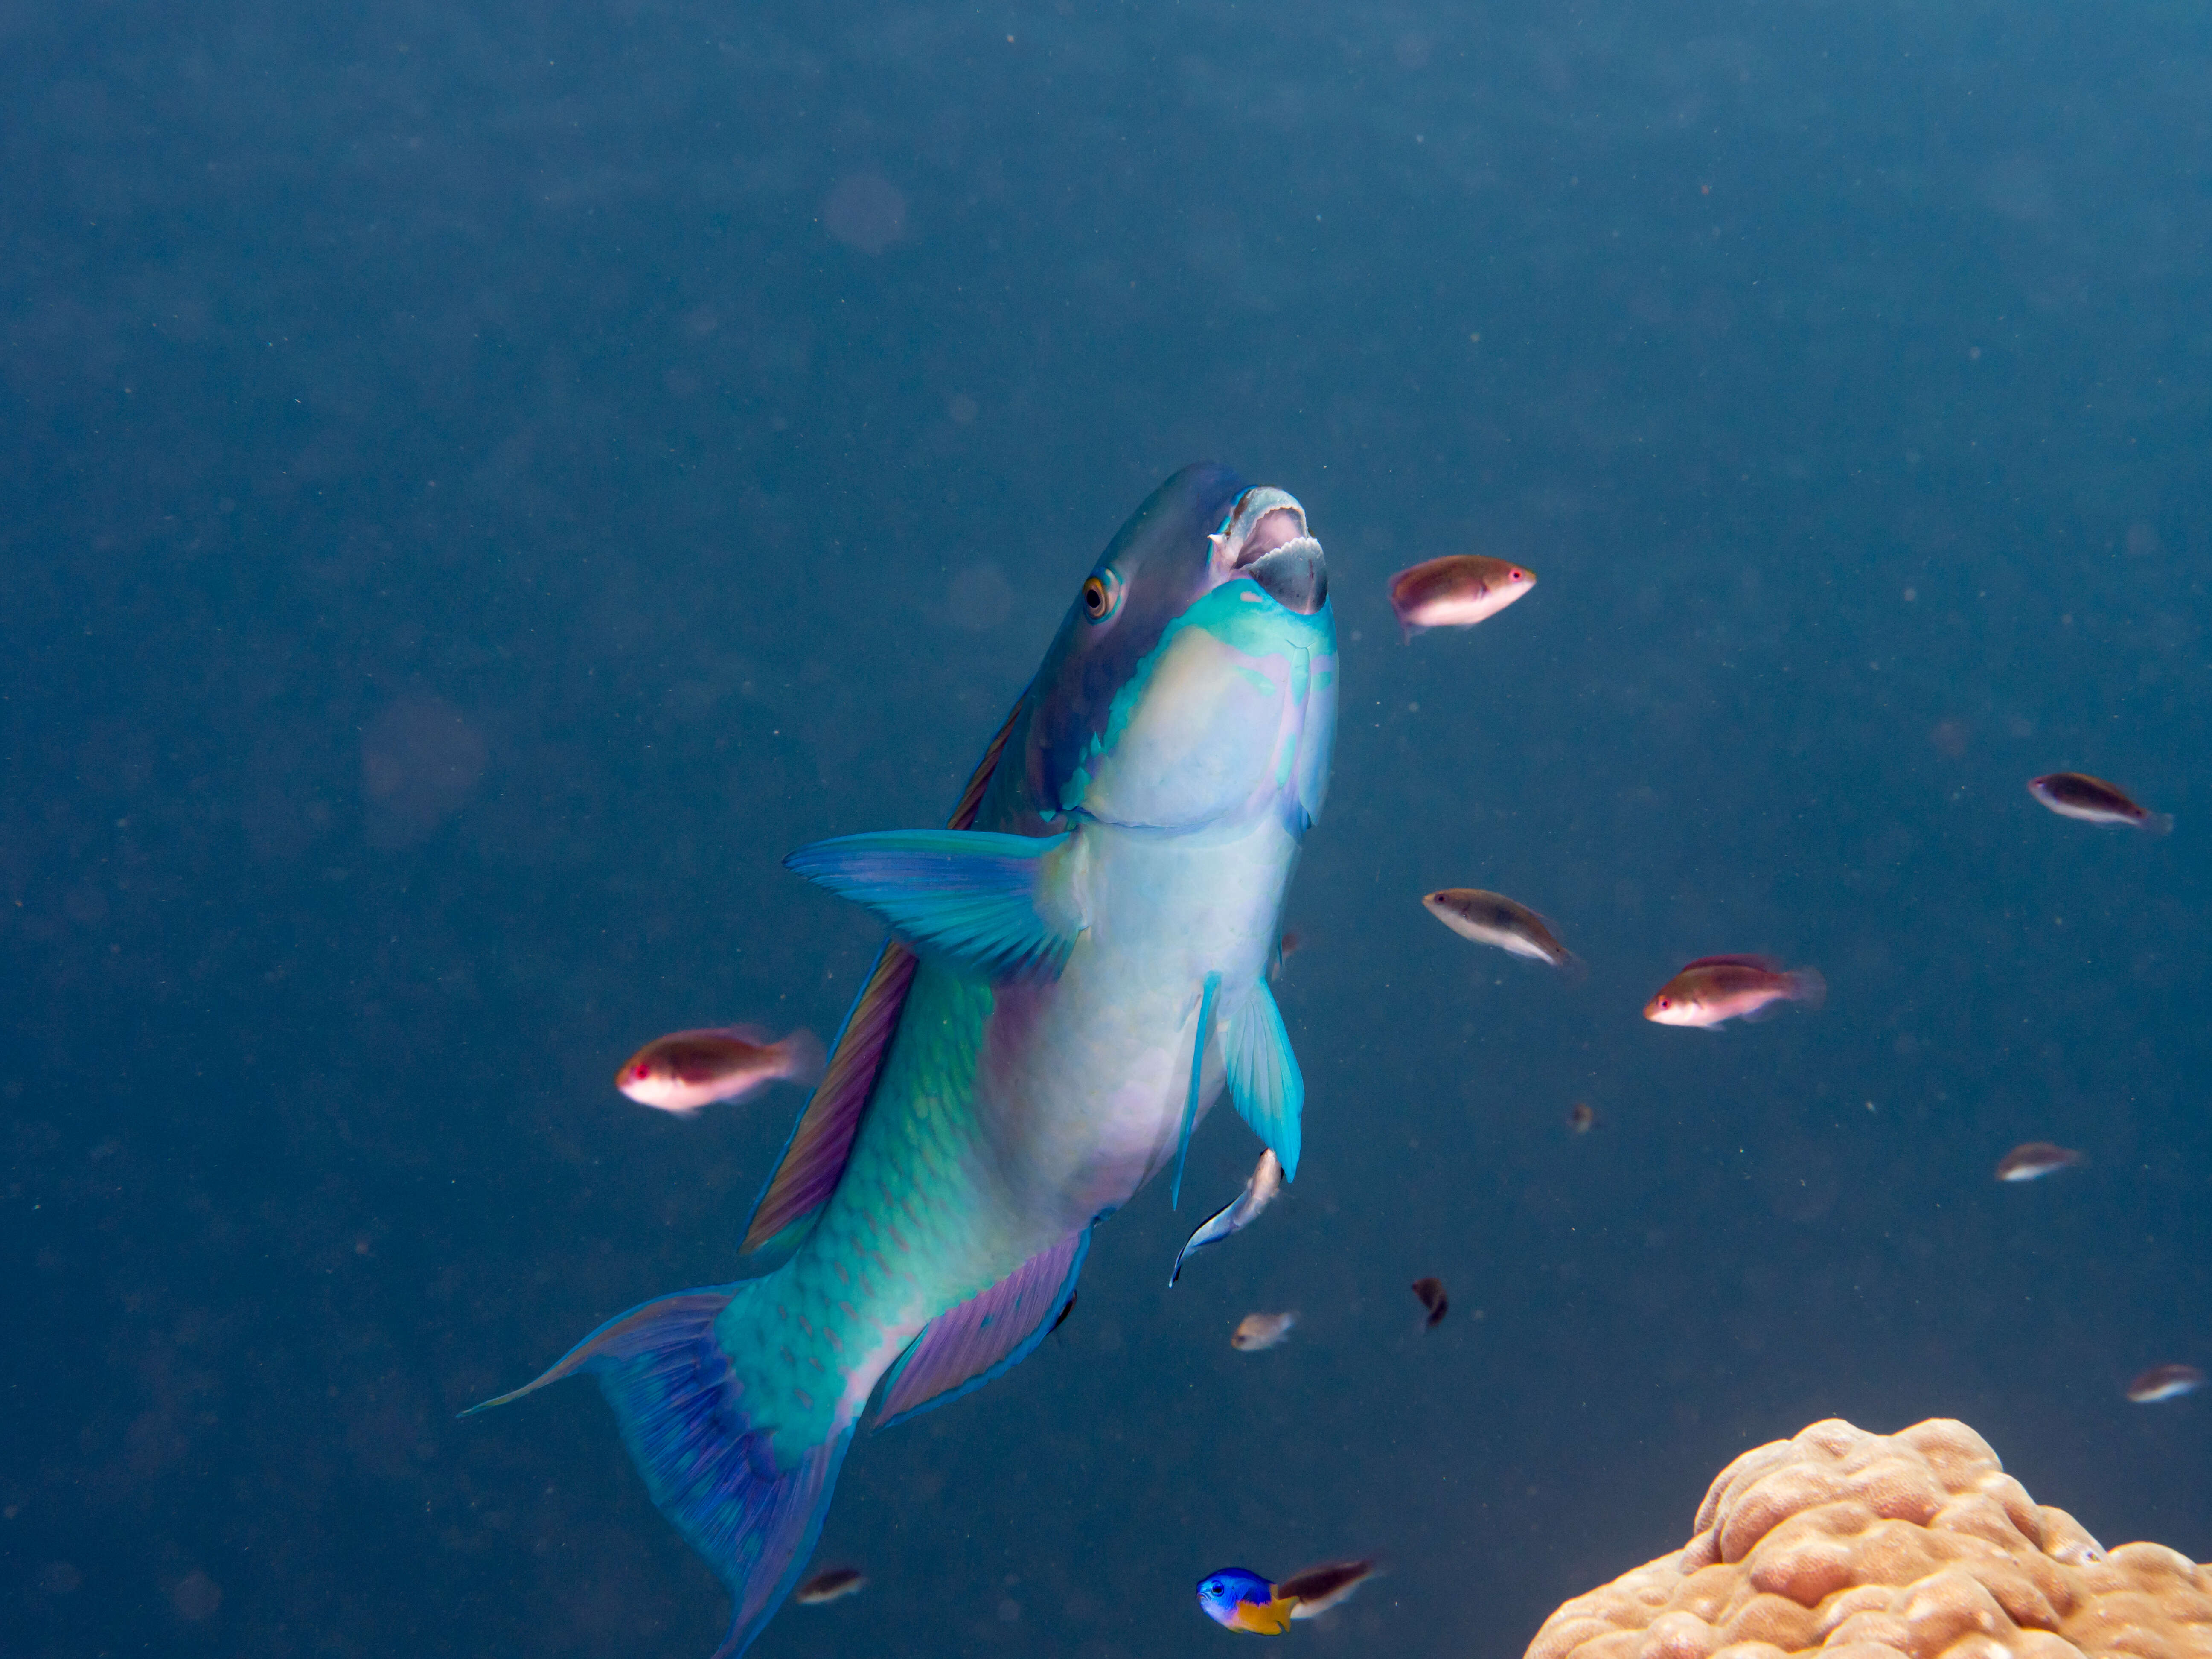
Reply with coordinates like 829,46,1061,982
1526,1418,2212,1659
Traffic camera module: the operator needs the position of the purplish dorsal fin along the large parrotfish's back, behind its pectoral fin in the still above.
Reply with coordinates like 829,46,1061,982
745,693,1026,1252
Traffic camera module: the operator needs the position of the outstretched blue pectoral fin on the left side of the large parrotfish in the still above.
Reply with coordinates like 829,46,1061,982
783,830,1089,980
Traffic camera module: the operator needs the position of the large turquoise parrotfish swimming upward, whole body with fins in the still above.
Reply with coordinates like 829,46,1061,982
464,467,1336,1657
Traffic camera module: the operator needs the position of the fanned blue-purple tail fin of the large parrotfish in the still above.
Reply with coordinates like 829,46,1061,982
462,1281,852,1659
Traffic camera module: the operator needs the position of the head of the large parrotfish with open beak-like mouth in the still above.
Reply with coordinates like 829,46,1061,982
1022,467,1336,834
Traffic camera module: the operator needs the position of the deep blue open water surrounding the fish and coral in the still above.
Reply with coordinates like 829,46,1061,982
0,0,2212,1659
